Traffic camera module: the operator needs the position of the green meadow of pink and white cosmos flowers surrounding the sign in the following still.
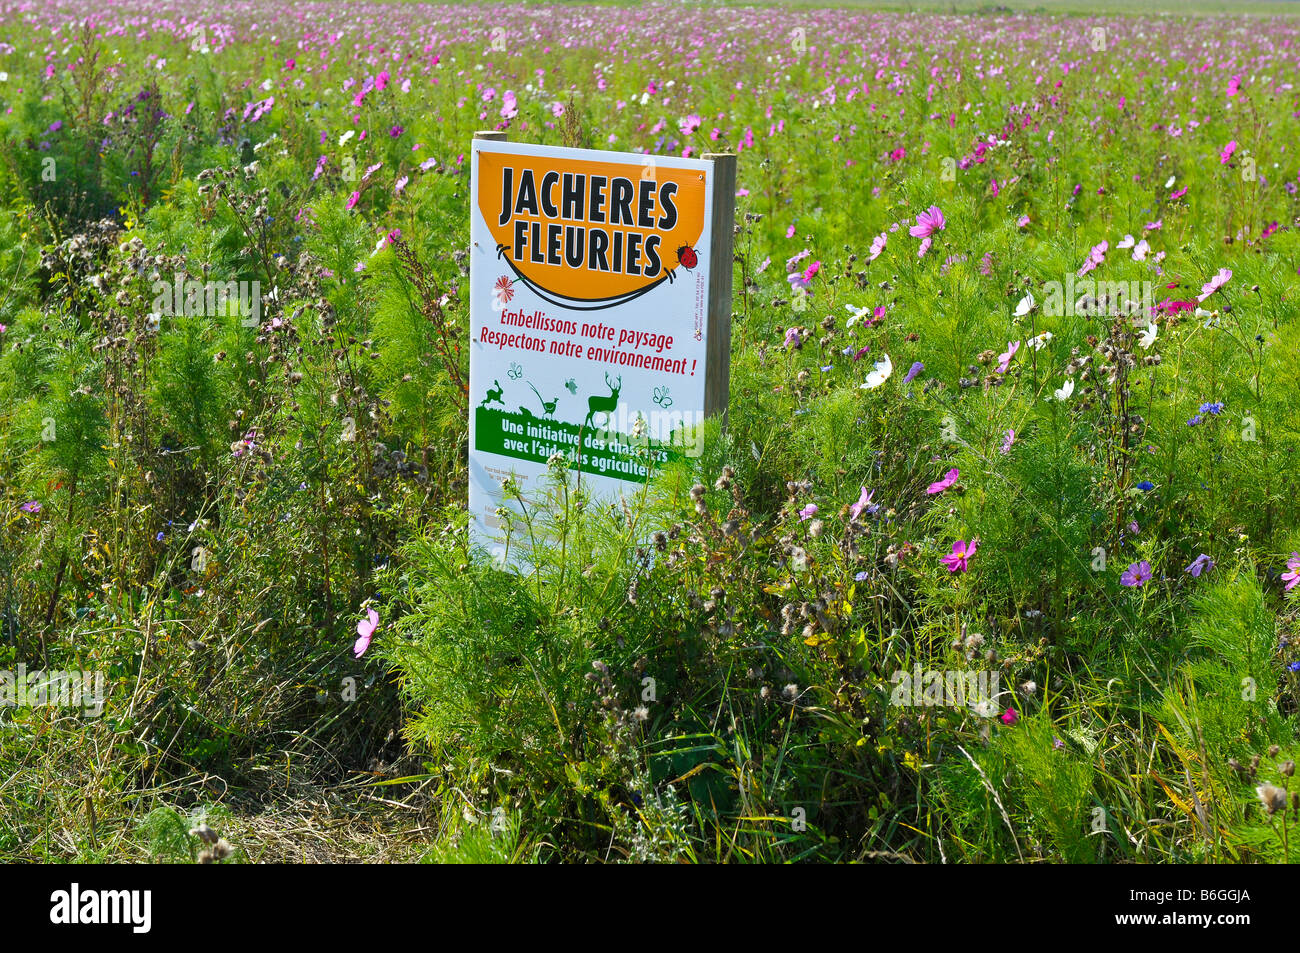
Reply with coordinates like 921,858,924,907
0,0,1300,863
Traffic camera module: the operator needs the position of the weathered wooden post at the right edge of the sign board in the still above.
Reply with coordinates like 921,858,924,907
703,152,736,424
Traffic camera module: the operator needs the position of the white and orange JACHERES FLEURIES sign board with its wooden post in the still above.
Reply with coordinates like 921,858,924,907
469,139,735,562
